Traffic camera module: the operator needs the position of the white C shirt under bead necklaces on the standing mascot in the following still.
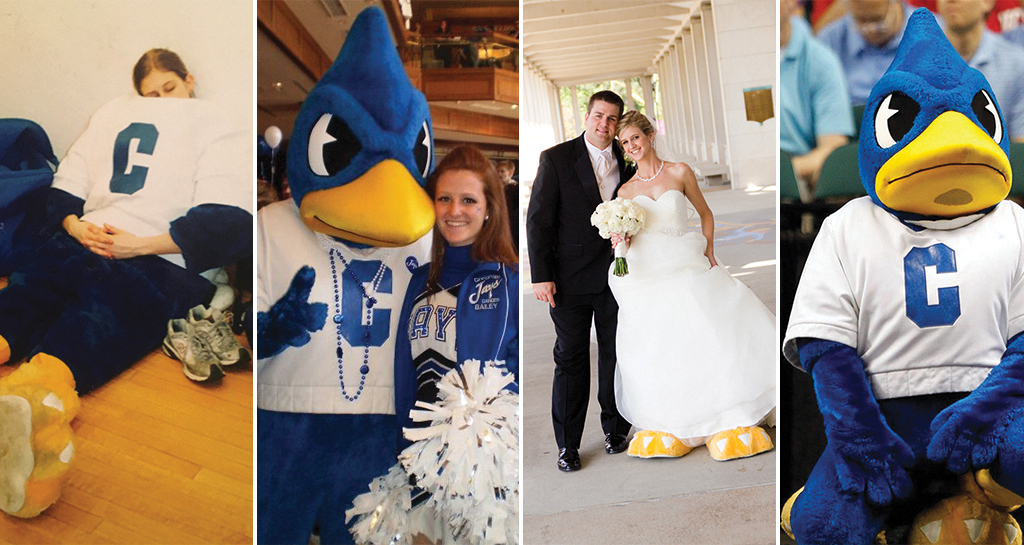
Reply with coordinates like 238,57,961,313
256,200,431,414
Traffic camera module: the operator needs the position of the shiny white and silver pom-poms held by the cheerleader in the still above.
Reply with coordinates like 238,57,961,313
346,360,519,545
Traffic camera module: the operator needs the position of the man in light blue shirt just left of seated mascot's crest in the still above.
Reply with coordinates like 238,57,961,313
818,0,911,106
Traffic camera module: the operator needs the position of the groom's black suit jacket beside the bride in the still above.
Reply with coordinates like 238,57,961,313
526,134,633,295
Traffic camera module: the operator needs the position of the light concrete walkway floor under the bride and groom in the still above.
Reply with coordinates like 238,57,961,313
521,187,778,545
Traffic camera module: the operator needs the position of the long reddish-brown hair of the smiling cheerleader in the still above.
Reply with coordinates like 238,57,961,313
427,145,519,293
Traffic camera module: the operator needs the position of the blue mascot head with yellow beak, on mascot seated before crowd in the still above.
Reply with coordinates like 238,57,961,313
859,8,1012,221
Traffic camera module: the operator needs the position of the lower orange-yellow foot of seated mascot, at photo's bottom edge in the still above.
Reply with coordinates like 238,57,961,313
907,494,1021,545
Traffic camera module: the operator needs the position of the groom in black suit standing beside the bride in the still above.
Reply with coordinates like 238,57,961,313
526,91,632,471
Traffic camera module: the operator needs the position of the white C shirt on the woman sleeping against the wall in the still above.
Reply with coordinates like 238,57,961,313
53,95,253,266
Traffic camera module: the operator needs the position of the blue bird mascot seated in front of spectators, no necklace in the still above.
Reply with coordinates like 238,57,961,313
782,9,1024,544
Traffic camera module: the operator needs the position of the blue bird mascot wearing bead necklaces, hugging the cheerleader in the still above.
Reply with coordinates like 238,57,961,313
257,7,434,544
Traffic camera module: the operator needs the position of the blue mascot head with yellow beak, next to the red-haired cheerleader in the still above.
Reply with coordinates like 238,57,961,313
288,7,434,247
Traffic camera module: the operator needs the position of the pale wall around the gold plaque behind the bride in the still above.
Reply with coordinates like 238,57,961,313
712,0,778,188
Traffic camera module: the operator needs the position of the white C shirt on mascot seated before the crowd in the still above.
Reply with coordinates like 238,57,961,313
783,197,1024,400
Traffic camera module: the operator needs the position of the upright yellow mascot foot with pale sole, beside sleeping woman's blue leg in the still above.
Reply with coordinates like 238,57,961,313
0,353,80,518
